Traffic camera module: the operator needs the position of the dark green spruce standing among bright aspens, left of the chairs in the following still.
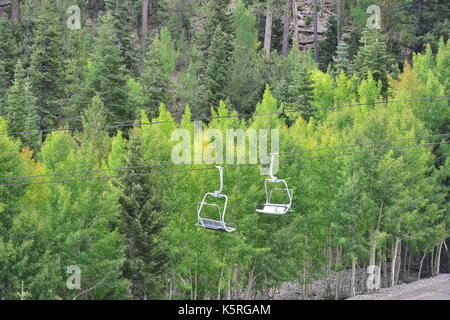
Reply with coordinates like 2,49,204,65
119,129,167,300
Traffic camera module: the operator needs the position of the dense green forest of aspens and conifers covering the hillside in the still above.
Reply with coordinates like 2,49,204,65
0,0,450,300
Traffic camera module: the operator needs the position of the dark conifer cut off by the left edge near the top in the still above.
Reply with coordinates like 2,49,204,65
0,13,18,88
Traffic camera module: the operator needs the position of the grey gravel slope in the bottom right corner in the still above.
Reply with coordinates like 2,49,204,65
348,274,450,300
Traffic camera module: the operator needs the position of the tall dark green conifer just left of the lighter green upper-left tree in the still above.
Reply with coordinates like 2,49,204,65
89,13,131,123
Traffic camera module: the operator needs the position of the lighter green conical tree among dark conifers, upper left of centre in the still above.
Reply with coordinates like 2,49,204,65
140,28,179,116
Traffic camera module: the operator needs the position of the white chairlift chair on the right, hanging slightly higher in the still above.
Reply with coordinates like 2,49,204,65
256,153,292,216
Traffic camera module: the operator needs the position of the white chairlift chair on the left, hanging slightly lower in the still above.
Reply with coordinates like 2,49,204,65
196,167,236,233
